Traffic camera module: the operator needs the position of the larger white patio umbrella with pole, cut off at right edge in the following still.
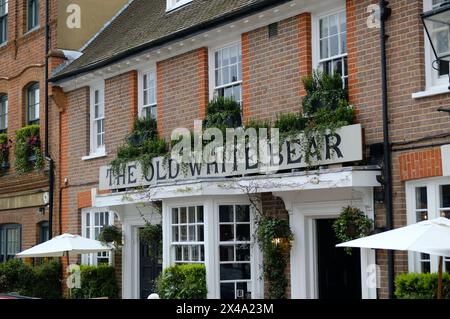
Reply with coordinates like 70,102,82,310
336,217,450,299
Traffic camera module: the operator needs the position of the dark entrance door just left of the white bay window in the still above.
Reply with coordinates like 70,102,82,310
139,238,162,299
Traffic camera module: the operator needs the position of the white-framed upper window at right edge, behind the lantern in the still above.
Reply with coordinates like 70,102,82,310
423,0,449,93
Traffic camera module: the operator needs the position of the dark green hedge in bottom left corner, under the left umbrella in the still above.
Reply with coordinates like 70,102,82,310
0,259,62,299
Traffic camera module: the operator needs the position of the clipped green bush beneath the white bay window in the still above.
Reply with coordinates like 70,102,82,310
156,265,208,299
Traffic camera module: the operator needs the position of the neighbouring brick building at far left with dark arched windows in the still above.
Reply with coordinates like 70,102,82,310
0,0,61,262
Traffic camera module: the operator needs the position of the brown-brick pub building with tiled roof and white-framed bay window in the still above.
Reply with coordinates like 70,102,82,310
49,0,450,298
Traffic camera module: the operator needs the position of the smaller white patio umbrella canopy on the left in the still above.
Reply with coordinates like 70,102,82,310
16,234,112,258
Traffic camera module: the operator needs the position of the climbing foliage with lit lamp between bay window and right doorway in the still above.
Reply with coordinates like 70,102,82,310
257,217,294,299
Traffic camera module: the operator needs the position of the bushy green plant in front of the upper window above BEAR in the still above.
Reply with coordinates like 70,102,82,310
302,71,348,115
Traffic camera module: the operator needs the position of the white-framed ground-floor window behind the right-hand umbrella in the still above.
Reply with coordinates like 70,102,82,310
405,177,450,273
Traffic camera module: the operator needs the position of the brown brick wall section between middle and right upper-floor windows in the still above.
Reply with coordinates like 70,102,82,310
242,17,307,121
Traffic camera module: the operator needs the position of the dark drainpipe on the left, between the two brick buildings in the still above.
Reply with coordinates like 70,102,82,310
44,0,55,239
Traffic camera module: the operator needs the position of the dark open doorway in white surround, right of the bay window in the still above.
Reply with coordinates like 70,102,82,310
316,219,362,299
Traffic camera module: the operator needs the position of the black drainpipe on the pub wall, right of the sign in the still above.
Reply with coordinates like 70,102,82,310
380,0,394,299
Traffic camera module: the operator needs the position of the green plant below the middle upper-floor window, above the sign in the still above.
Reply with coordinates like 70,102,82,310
203,97,242,132
